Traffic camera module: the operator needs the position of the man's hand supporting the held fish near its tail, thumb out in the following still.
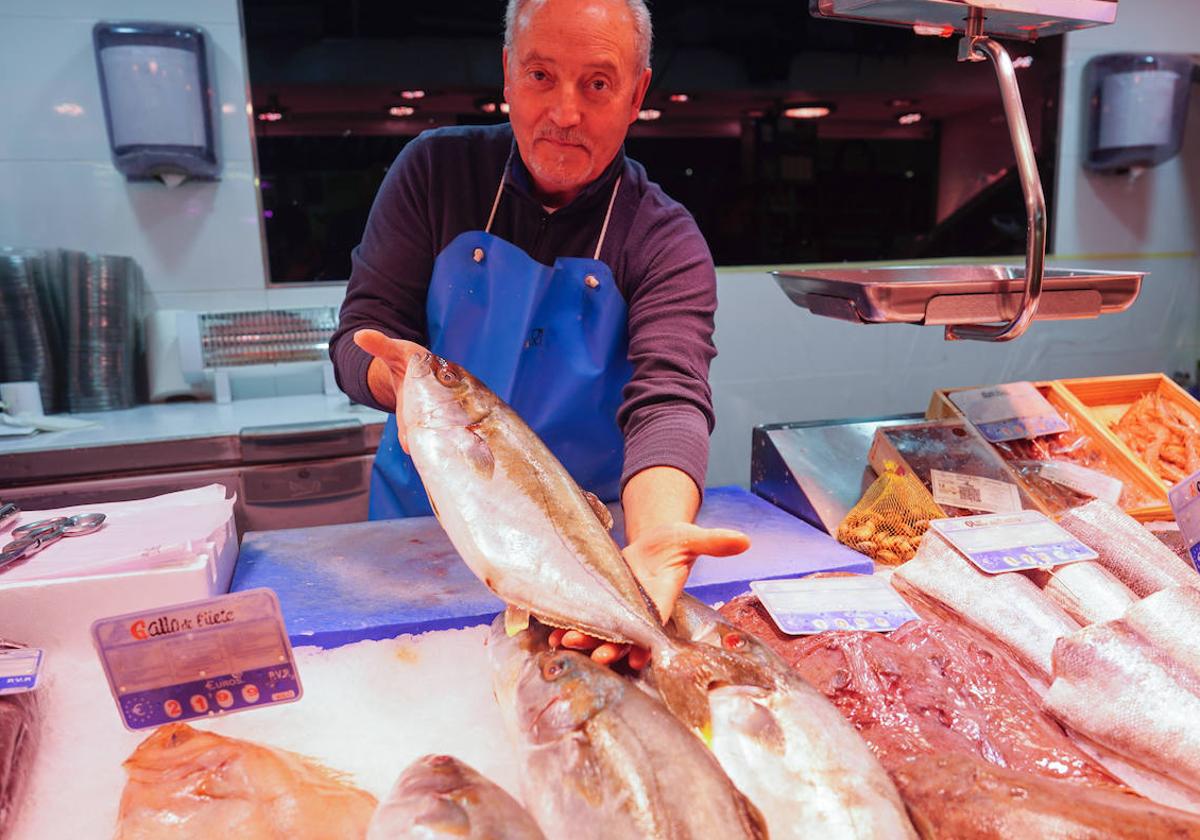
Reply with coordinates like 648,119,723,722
550,522,750,670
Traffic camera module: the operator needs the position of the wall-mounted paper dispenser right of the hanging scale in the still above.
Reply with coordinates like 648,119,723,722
1084,53,1194,172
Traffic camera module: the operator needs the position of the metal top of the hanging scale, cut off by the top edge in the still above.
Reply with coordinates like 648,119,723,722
810,0,1117,41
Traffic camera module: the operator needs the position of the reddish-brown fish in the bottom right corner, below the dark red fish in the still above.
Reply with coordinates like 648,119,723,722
894,754,1200,840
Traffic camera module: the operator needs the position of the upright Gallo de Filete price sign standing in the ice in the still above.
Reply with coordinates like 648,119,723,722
91,589,302,730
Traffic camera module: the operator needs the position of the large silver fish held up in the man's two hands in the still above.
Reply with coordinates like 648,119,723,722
403,353,766,734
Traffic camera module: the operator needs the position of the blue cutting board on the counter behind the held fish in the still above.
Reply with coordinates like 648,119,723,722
232,487,872,648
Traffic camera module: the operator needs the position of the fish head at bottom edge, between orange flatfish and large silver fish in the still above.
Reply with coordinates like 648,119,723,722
366,755,545,840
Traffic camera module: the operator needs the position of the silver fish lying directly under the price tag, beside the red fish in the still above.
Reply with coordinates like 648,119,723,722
892,532,1079,683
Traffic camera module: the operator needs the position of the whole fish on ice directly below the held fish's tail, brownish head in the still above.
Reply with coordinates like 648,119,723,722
487,609,768,840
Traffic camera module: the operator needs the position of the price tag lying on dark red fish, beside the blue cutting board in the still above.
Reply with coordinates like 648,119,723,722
750,575,919,636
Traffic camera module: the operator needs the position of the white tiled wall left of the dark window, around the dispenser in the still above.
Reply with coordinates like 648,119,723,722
0,0,266,307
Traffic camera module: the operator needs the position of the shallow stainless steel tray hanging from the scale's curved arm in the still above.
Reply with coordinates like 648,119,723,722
772,265,1145,326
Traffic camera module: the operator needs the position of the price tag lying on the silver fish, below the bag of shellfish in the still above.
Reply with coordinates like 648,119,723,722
929,510,1099,575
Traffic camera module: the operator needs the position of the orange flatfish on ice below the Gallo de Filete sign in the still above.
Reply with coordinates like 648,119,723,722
116,724,377,840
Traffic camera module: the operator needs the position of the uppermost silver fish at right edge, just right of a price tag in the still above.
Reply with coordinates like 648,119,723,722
1058,499,1200,598
